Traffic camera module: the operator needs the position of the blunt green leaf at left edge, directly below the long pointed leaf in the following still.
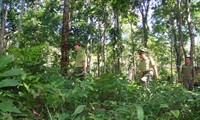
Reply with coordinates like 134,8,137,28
0,79,20,88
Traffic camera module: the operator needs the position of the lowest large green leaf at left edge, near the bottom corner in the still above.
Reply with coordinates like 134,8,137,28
0,100,21,113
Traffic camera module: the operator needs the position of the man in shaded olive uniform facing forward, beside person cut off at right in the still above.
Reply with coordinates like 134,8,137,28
179,56,194,91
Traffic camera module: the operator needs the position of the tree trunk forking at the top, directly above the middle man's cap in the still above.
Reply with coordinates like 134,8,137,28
139,0,150,47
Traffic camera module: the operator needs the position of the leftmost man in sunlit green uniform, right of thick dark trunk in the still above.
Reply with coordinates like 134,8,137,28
74,42,87,80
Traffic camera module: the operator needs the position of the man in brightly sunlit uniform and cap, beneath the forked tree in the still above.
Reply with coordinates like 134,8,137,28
138,48,158,85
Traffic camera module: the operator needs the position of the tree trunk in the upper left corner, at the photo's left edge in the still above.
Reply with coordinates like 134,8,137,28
0,0,8,55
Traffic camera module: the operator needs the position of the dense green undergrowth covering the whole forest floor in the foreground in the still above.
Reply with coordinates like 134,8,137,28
0,56,200,120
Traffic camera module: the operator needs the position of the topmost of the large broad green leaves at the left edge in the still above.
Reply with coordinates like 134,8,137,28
0,55,13,70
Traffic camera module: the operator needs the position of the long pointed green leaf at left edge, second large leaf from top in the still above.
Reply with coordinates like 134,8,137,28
0,69,24,77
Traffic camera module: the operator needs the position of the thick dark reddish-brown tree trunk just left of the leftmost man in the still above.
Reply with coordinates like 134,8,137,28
61,0,70,76
